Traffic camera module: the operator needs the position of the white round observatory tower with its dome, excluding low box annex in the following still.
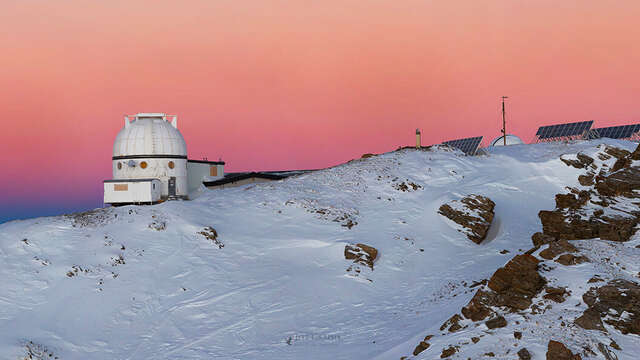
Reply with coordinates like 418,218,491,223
112,113,189,199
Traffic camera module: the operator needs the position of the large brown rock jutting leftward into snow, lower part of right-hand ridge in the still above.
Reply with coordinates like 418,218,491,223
462,254,546,321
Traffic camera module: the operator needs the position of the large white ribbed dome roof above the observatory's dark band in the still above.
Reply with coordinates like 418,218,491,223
113,113,187,158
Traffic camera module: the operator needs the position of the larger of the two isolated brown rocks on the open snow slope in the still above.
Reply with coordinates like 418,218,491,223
438,194,496,244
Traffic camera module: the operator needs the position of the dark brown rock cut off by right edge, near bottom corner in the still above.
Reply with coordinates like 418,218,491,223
575,279,640,335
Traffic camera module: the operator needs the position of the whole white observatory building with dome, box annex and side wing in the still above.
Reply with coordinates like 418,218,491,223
104,113,224,205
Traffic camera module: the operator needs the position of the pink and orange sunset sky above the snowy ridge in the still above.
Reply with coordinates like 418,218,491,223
0,0,640,222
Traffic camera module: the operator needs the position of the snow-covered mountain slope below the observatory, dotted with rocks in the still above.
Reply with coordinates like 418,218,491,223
0,140,640,359
